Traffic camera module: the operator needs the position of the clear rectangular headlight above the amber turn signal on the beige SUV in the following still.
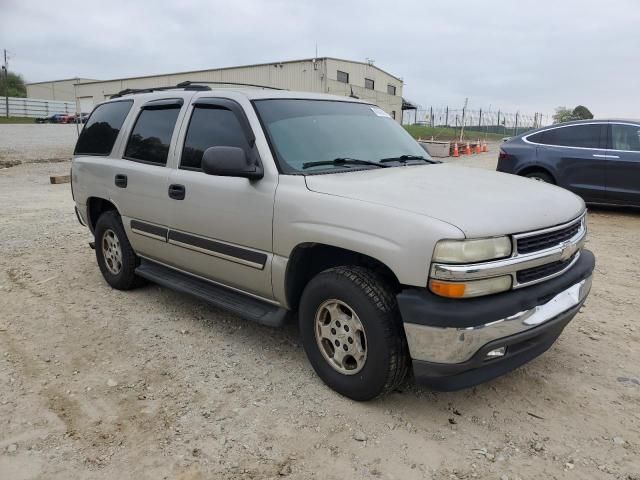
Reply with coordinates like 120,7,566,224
433,237,511,263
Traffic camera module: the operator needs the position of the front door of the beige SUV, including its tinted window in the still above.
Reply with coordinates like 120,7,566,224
164,98,278,299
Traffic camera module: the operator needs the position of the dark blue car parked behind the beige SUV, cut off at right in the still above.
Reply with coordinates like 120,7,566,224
497,120,640,206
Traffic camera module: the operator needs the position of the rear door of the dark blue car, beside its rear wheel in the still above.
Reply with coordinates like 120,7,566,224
537,123,607,202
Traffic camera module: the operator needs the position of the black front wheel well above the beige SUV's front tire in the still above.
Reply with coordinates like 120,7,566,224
285,243,400,309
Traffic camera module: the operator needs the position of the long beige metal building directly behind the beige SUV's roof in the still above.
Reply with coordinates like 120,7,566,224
70,57,402,122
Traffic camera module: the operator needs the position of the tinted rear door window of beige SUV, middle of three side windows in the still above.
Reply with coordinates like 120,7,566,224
124,108,180,165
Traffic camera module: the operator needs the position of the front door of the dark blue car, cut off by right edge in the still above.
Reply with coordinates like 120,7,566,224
606,122,640,205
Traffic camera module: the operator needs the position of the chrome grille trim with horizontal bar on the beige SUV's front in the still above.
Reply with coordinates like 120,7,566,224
430,217,587,288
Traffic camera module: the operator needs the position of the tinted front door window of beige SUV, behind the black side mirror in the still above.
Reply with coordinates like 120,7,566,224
180,106,250,170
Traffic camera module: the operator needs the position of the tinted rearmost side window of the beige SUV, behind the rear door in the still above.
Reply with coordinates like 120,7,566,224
74,100,133,155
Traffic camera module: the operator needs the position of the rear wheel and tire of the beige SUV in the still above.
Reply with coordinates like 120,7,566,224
95,210,144,290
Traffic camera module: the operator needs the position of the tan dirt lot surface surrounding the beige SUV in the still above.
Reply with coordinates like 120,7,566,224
0,142,640,480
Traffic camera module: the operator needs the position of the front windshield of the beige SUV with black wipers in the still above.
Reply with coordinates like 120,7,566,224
255,99,430,173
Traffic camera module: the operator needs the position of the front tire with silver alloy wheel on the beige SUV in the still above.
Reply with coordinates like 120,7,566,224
299,266,408,401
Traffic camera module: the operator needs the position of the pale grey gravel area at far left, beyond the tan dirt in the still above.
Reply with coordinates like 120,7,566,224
0,124,82,168
